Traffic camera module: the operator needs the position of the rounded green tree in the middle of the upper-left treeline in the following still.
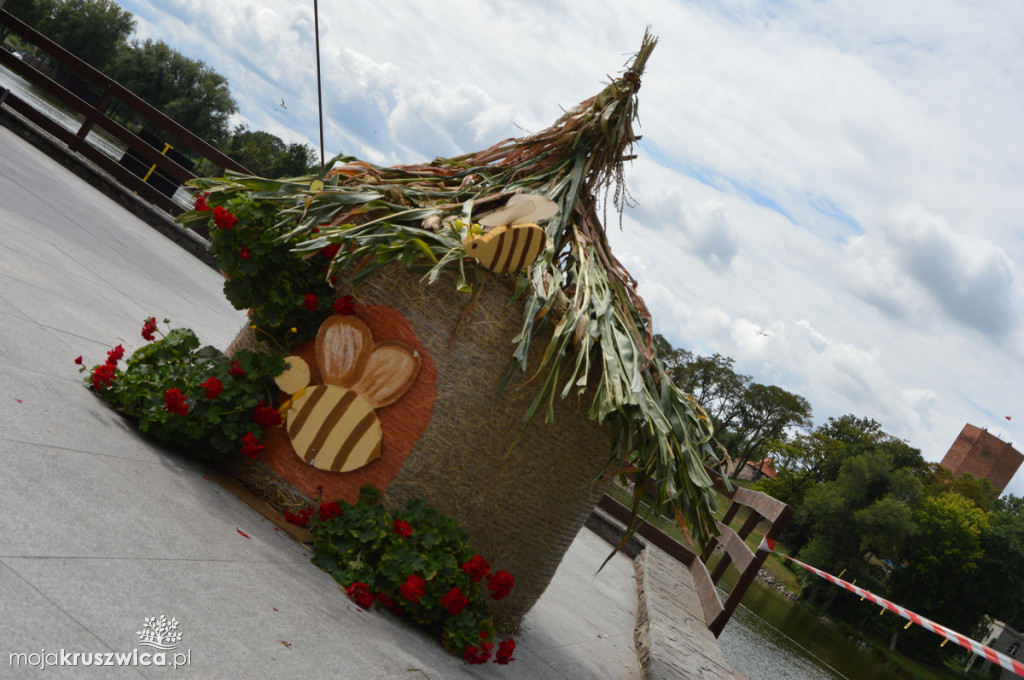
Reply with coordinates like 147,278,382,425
110,40,238,144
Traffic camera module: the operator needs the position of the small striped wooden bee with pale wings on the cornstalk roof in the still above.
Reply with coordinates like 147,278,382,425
463,194,558,273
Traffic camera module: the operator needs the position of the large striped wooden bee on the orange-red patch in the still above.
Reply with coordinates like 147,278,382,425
275,314,421,472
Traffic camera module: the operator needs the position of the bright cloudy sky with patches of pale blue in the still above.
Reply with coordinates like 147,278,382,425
114,0,1024,496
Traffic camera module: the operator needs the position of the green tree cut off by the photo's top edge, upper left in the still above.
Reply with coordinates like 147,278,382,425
33,0,135,72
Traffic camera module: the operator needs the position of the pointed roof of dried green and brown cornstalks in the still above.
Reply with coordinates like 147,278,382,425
182,34,719,541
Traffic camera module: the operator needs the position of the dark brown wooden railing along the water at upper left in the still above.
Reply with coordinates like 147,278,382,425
0,10,247,214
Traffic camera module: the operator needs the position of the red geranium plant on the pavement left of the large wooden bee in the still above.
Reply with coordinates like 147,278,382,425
76,317,284,461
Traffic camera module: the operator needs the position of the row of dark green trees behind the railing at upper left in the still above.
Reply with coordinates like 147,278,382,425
3,0,319,177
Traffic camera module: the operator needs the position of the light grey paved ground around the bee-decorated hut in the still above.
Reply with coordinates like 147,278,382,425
0,127,641,680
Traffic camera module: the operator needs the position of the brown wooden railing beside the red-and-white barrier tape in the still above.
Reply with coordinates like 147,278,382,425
598,470,793,637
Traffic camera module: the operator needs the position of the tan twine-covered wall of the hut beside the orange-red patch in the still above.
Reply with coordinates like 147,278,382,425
227,265,610,631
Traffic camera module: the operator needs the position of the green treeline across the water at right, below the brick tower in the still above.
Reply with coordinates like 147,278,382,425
655,336,1024,665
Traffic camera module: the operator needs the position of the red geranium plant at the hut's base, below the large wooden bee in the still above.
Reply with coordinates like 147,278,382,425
296,486,515,664
